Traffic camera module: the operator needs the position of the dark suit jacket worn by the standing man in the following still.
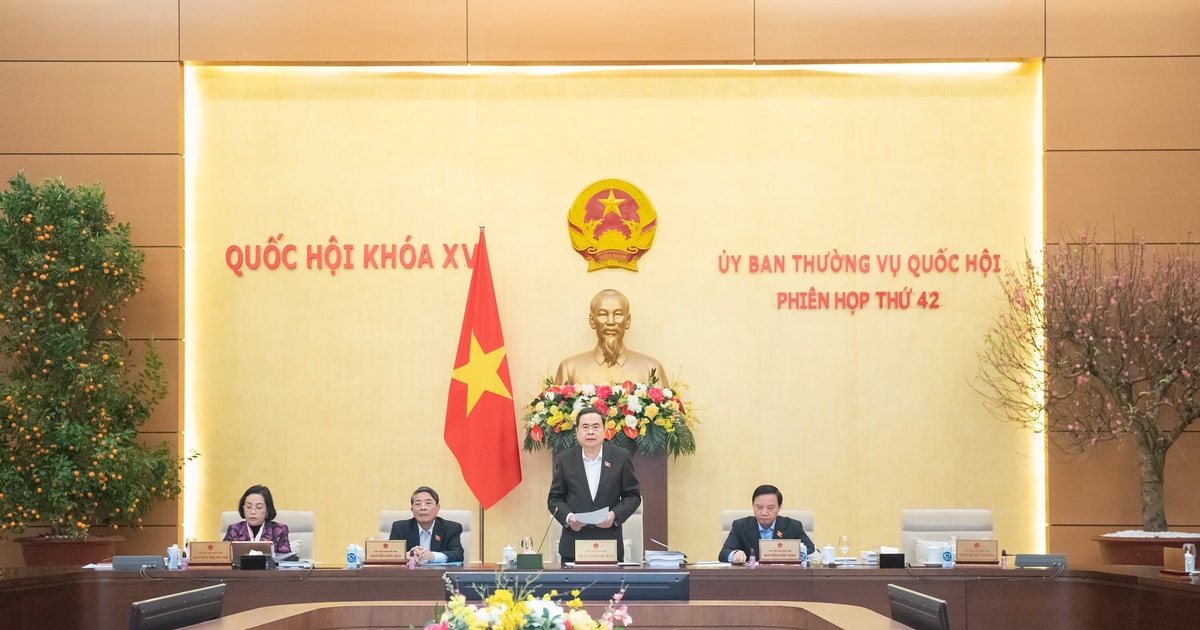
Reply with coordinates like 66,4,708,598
546,444,642,562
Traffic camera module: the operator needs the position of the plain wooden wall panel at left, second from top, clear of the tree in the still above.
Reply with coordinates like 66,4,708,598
0,61,182,154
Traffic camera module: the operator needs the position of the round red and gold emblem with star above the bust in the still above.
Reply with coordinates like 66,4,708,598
566,179,659,271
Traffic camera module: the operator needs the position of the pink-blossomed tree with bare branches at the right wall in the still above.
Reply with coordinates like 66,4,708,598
978,235,1200,564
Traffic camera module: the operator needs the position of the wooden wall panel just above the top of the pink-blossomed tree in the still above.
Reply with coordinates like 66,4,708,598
1045,151,1200,242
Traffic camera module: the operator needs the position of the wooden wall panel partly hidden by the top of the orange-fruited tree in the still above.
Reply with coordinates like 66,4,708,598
0,154,184,247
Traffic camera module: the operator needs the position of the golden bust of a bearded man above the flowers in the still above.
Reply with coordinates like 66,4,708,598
554,289,670,388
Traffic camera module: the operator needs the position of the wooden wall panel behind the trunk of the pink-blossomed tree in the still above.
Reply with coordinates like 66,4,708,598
1046,432,1200,525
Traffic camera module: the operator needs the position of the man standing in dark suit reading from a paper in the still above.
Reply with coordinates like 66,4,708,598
546,407,642,564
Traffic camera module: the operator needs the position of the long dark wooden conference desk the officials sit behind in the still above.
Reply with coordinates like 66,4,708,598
0,566,1200,630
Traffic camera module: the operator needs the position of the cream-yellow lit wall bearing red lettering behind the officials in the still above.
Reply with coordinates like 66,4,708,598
185,62,1044,563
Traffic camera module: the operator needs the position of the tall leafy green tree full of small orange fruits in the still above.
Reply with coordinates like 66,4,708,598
0,174,181,564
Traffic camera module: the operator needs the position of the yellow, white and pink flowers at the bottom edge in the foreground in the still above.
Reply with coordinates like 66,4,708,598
425,574,634,630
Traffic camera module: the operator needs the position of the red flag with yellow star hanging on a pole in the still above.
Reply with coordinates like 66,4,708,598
445,228,521,510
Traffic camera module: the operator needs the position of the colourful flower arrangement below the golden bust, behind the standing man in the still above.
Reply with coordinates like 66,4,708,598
523,373,696,457
